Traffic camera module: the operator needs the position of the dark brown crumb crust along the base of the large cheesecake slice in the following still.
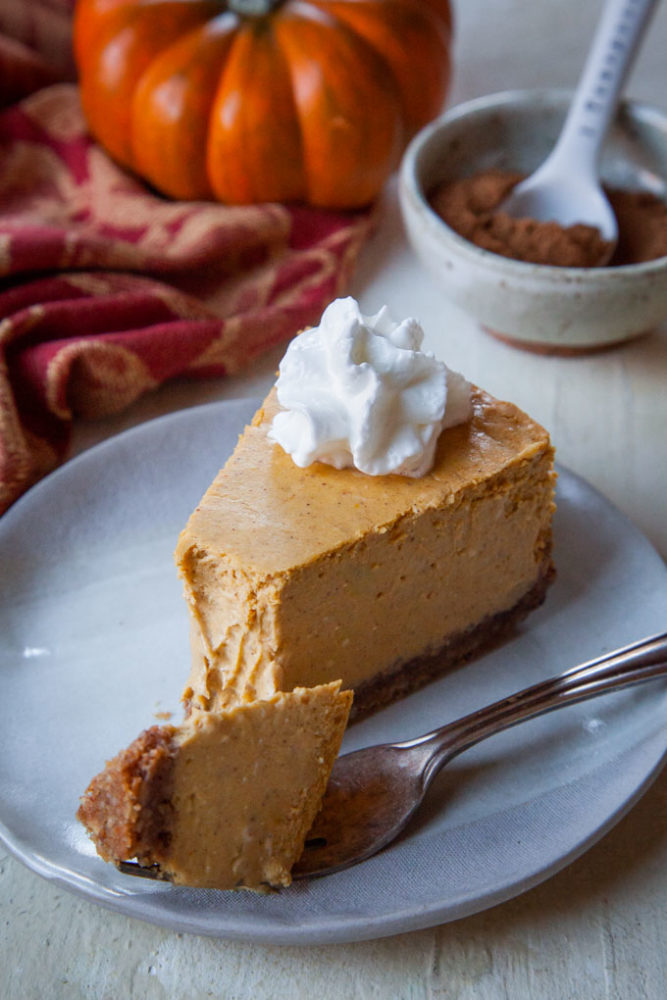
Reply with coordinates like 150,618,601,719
350,560,556,722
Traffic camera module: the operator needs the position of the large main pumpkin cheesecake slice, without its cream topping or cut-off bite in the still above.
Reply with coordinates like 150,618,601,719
176,378,555,714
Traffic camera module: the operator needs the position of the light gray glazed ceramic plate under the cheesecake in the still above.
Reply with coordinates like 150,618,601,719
0,401,667,944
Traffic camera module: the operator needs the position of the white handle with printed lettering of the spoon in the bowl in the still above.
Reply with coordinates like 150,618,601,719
549,0,658,172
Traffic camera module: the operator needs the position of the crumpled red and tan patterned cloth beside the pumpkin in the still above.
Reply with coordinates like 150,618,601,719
0,0,370,513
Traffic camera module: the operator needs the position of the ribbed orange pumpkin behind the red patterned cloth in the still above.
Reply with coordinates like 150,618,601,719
74,0,451,208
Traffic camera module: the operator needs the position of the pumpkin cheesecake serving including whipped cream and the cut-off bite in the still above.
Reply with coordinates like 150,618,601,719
78,299,555,889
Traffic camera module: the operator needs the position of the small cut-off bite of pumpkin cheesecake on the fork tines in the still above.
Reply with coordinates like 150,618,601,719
77,683,352,890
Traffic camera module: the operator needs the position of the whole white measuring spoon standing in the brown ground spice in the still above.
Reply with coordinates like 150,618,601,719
500,0,658,250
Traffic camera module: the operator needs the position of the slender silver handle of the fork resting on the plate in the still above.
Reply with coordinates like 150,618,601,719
404,633,667,788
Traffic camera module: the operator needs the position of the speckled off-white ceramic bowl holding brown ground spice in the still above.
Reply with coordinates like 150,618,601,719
399,90,667,353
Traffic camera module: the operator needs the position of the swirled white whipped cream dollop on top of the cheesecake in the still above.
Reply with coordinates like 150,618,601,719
269,298,472,476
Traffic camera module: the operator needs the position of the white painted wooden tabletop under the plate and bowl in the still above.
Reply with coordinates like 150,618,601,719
0,0,667,1000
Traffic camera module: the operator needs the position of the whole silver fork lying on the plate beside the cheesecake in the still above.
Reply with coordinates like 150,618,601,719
292,633,667,878
